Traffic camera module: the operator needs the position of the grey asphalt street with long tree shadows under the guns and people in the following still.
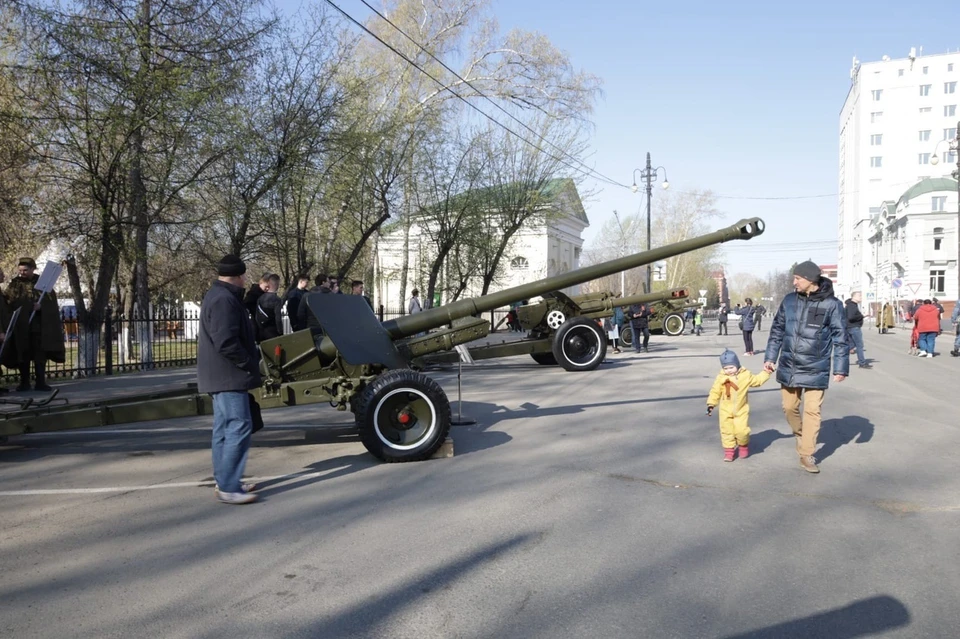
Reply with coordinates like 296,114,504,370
0,328,960,639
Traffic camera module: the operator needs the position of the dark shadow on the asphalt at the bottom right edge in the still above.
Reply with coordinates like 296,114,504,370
726,595,910,639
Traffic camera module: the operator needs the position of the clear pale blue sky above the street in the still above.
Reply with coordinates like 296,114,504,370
292,0,960,276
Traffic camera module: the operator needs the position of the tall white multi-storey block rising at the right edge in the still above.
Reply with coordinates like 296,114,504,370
837,49,960,294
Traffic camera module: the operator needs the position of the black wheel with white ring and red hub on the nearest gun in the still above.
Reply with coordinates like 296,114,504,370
355,368,450,462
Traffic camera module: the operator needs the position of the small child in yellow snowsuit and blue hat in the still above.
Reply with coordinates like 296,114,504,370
707,349,770,461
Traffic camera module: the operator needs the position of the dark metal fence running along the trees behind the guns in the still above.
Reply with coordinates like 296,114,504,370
0,305,509,383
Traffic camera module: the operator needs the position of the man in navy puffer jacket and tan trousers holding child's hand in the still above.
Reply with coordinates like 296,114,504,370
763,261,850,473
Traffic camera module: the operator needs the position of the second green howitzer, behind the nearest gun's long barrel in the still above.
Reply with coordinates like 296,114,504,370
414,288,689,371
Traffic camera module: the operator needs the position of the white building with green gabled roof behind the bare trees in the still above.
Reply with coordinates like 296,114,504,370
372,179,590,309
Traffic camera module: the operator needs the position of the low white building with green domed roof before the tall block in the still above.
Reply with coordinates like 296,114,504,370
852,178,960,310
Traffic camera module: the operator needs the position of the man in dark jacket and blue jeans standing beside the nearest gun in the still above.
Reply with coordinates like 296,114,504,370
197,255,261,504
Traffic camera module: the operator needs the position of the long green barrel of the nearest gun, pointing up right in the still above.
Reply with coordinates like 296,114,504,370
383,218,764,339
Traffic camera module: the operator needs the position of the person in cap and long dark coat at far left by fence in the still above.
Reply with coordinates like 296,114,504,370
3,257,66,391
